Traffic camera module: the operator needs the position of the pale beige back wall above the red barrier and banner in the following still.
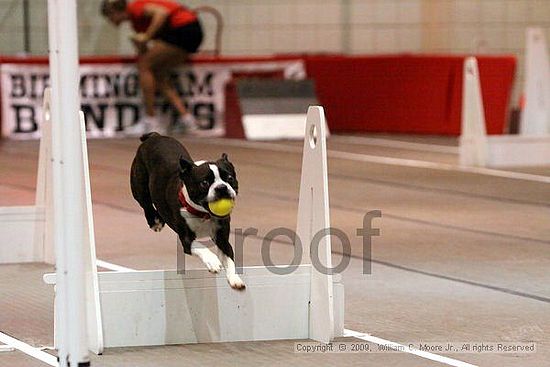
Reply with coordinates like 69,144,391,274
0,0,550,103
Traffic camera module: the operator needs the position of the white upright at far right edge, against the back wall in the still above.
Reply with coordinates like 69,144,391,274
520,28,550,135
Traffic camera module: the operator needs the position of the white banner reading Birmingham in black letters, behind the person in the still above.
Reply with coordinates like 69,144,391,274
0,60,305,139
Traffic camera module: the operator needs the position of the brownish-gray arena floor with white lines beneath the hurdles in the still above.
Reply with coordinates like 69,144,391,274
0,136,550,367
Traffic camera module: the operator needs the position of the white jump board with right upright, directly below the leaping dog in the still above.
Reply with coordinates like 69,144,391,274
44,107,344,351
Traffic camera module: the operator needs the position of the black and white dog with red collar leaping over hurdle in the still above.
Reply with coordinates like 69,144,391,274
130,132,245,289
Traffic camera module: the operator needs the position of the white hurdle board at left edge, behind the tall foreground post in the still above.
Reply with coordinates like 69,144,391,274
0,206,44,264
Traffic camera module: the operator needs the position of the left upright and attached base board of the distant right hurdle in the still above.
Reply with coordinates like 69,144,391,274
459,57,550,167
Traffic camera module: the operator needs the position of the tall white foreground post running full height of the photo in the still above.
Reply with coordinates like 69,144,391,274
48,0,89,366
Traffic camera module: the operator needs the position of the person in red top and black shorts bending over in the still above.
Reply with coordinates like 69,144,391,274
101,0,203,134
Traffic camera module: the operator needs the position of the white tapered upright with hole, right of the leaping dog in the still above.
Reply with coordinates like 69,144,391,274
296,106,334,343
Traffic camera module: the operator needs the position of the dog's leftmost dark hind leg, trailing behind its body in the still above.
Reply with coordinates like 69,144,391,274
130,160,164,232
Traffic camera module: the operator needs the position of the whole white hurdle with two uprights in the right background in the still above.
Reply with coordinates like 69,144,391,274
460,29,550,167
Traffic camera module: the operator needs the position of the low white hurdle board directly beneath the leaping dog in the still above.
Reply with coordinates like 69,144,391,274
45,265,344,348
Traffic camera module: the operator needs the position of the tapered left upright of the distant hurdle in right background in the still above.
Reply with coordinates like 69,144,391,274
460,57,488,166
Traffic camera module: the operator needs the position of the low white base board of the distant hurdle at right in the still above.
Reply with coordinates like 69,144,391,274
460,135,550,167
